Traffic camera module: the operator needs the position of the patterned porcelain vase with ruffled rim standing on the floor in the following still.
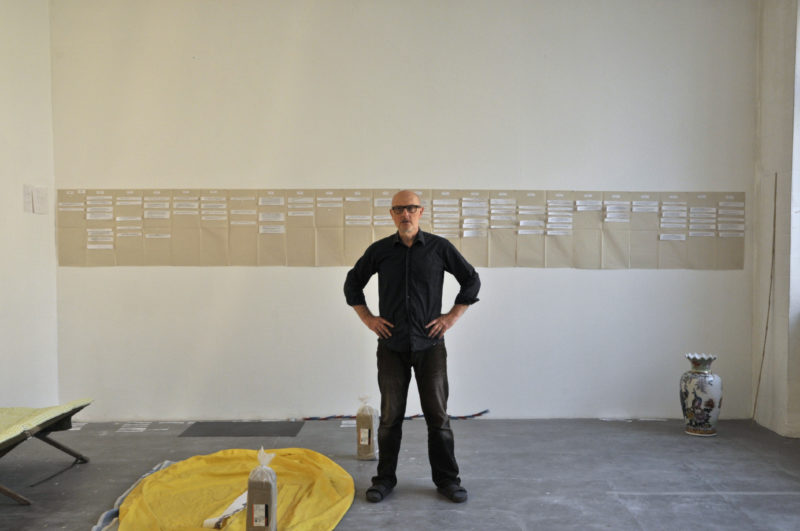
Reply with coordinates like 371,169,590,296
680,354,722,436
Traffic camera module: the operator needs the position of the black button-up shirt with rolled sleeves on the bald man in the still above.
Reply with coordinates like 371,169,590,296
344,231,481,352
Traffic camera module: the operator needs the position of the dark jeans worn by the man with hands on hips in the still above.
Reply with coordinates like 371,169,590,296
372,343,461,487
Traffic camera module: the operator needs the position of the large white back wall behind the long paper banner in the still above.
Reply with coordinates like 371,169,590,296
52,0,758,420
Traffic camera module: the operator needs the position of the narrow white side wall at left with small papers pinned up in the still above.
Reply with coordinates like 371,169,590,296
0,0,58,406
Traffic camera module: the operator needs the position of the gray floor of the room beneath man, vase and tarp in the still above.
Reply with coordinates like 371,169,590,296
0,419,800,531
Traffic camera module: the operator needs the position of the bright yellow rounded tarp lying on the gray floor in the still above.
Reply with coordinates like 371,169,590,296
119,448,355,531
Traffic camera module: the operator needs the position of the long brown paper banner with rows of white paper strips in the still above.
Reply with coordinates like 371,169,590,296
56,189,746,270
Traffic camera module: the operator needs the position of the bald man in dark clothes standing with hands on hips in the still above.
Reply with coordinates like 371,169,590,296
344,190,481,503
